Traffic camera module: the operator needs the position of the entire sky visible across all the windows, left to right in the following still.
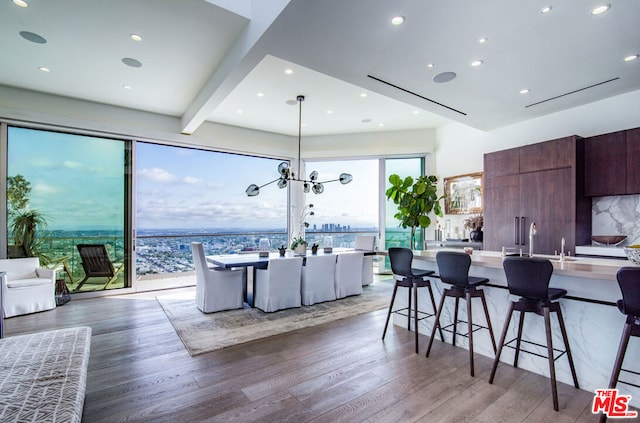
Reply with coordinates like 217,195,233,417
8,127,416,230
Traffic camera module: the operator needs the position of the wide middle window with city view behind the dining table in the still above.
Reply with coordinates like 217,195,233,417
135,142,288,279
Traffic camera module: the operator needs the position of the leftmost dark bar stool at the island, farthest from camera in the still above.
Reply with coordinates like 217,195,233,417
382,248,444,354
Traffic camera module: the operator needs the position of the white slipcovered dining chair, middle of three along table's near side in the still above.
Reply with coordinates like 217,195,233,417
300,254,336,305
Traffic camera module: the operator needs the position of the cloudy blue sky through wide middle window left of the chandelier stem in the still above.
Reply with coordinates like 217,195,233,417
136,143,287,229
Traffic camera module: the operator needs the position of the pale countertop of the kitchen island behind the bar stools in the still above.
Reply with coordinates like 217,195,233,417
413,249,635,281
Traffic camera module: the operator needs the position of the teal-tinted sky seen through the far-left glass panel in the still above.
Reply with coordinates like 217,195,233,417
7,127,124,230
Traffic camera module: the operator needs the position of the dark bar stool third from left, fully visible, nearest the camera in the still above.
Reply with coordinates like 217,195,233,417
489,257,580,411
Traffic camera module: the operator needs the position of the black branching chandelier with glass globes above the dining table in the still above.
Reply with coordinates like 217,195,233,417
245,95,353,197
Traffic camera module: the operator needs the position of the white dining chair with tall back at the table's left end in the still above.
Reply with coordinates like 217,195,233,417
191,242,245,313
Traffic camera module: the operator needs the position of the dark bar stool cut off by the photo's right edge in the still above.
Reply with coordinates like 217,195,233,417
600,267,640,422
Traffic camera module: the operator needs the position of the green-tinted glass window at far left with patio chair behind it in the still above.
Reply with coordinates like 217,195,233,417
6,127,130,291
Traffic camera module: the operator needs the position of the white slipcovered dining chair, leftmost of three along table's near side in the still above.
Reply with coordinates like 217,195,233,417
254,257,302,312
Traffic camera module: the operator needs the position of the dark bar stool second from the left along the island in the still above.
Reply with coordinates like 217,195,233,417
427,251,496,377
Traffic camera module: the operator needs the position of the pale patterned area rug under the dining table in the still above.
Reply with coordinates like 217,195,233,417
156,279,393,356
